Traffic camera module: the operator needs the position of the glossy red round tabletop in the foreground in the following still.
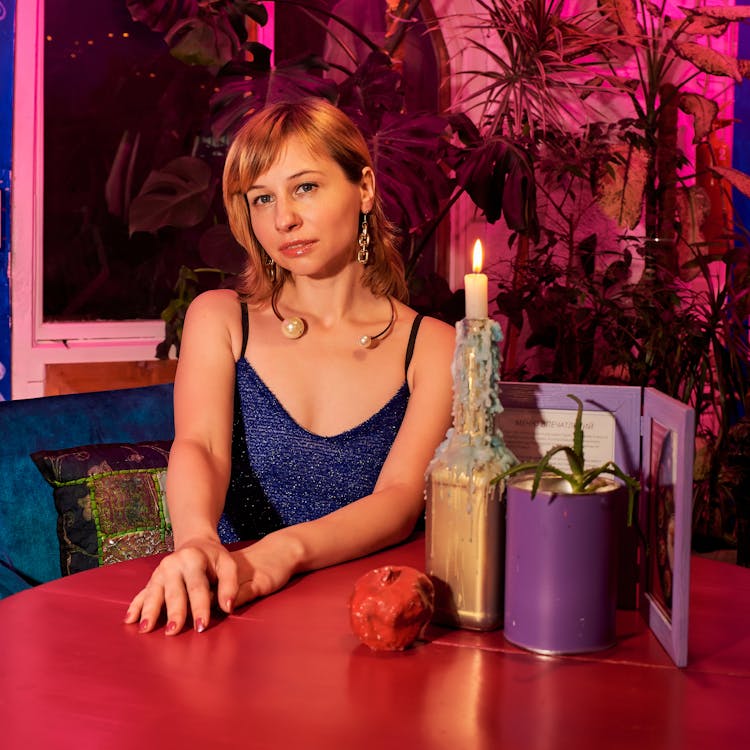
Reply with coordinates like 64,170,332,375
0,537,750,750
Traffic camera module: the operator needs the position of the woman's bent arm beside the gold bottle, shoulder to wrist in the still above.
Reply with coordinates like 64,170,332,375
229,318,455,604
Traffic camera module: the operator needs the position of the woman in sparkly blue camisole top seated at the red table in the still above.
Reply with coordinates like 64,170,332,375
125,100,454,635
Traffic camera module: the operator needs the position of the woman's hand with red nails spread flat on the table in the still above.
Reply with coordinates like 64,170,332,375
125,539,238,635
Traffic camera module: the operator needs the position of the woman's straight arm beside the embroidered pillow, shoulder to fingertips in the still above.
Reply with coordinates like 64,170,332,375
125,291,239,634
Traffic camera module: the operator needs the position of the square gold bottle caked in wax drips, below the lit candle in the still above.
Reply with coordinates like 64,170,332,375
425,318,515,630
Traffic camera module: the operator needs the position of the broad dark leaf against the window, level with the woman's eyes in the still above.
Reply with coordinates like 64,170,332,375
130,156,214,234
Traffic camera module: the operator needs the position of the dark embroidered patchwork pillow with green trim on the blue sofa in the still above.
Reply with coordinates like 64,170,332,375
31,441,173,575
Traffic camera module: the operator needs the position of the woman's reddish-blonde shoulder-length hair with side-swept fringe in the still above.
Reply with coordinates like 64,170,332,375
223,98,408,302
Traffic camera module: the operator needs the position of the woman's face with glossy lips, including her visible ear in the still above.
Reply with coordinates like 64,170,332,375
247,137,374,278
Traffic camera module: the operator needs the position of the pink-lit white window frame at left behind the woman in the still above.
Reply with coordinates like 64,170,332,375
10,0,273,399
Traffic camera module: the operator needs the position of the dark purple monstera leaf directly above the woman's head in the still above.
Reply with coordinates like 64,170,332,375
210,42,337,138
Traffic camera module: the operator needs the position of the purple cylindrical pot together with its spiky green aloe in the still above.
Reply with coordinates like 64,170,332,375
495,394,639,654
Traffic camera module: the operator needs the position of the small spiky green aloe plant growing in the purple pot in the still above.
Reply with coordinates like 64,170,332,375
493,393,640,526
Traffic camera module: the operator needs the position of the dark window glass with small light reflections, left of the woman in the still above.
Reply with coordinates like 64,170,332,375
43,0,212,321
